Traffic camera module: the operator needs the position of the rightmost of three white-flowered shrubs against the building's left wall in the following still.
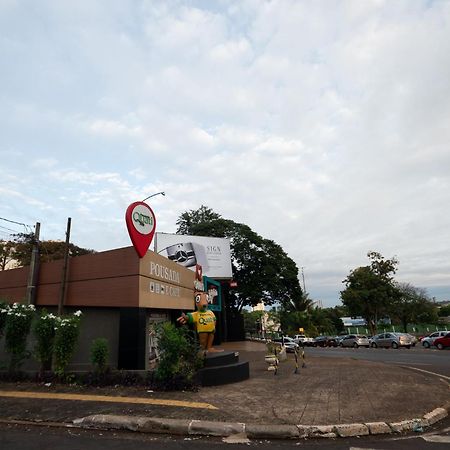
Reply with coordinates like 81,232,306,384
53,311,81,377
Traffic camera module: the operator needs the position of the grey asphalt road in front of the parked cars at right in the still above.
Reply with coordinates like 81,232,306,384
305,346,450,381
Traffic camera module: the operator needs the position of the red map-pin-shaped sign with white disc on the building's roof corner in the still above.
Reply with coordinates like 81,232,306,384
125,202,156,258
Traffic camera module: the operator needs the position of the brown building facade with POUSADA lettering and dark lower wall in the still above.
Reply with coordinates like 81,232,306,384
0,247,195,370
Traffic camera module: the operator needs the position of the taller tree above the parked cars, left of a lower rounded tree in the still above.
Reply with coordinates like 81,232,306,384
341,252,399,334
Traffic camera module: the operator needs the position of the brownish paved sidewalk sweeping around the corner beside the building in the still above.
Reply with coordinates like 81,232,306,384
0,342,450,435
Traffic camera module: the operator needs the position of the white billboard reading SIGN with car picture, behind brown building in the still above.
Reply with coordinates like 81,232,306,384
155,233,232,279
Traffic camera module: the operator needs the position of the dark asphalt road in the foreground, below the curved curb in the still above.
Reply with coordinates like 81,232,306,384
0,420,450,450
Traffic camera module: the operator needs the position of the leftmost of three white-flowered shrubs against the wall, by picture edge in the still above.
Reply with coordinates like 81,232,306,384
5,303,36,372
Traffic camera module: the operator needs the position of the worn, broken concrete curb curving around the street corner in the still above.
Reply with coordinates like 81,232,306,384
73,405,450,439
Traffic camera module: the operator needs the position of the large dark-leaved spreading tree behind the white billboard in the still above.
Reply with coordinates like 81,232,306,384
177,206,302,312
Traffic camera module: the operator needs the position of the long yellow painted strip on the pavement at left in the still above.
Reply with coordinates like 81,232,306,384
0,391,218,409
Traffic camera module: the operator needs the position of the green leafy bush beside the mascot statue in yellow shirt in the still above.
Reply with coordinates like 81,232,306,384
155,322,203,389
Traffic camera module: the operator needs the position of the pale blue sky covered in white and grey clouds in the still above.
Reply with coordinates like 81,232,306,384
0,0,450,306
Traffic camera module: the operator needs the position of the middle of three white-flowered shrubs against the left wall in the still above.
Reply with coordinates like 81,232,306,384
33,309,58,373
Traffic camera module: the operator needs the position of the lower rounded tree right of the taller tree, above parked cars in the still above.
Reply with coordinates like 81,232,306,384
389,283,437,333
